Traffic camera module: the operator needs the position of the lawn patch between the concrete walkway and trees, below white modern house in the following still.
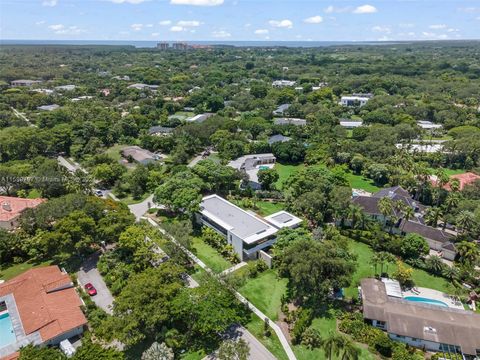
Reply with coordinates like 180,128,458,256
238,269,287,321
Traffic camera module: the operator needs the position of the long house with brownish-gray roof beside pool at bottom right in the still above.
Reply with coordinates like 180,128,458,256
360,279,480,359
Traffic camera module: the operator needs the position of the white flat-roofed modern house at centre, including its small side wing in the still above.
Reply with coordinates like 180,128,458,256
197,194,301,261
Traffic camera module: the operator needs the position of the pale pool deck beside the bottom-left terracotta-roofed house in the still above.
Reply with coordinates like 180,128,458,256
0,294,43,358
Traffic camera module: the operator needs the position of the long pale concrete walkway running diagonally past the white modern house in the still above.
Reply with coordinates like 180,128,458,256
144,218,297,360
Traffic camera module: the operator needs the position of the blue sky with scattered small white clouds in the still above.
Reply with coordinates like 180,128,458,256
0,0,480,41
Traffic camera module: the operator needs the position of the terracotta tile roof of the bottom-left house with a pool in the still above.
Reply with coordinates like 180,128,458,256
0,266,87,341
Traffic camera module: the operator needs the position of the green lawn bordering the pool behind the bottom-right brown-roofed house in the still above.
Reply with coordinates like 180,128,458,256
345,239,450,297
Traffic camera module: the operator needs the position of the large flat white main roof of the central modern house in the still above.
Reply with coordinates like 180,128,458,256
200,195,278,244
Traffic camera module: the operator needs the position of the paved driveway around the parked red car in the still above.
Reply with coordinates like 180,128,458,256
77,253,113,314
